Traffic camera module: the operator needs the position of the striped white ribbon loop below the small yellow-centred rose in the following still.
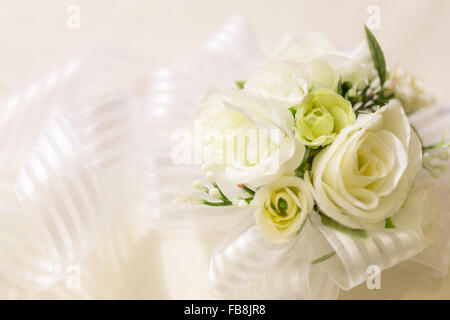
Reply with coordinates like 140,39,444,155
208,212,339,299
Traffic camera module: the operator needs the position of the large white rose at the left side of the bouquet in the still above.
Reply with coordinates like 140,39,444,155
194,90,305,187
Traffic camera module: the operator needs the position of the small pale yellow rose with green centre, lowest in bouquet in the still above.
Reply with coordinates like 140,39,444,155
252,176,314,243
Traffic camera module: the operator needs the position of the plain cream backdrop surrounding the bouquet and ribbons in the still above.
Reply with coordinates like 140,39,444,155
0,0,450,299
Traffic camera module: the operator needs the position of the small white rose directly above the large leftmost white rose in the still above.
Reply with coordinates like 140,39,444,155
244,61,310,106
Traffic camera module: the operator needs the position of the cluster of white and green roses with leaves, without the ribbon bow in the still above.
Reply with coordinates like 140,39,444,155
186,28,440,242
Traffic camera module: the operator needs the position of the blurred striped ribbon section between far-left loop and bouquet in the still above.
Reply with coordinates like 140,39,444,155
142,15,263,229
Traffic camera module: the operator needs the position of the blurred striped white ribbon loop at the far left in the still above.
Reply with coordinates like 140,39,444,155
0,48,149,289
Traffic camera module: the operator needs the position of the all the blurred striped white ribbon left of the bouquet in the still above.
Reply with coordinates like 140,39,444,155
0,15,262,289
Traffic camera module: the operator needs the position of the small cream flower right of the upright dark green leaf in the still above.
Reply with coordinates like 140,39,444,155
387,67,435,113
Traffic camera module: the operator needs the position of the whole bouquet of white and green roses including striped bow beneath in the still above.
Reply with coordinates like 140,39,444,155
182,27,449,298
